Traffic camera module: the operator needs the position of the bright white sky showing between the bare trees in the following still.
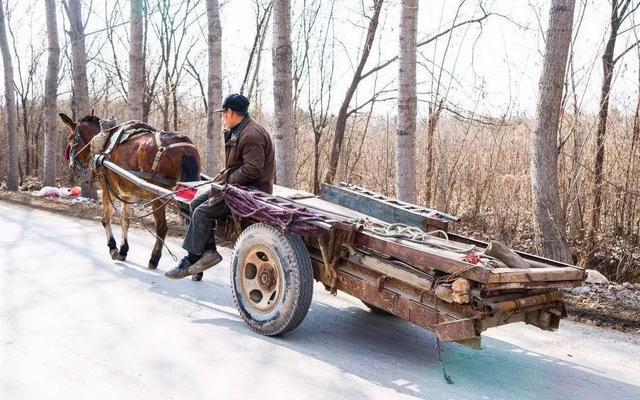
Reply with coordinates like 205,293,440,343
1,0,638,122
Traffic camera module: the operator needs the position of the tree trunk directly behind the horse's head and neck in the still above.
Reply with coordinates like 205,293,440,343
67,0,98,199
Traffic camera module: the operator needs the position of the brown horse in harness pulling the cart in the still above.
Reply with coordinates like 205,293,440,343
59,114,200,269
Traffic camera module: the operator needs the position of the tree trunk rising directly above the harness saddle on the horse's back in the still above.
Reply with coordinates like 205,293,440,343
127,0,144,120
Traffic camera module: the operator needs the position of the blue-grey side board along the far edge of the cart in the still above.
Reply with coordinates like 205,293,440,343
321,184,448,231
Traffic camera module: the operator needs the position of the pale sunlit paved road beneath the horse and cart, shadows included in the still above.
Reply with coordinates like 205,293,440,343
0,203,640,400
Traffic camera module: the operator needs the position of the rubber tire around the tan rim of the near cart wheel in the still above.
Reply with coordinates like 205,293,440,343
231,223,313,336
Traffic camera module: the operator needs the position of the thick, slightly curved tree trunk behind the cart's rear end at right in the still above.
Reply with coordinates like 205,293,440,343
531,0,575,262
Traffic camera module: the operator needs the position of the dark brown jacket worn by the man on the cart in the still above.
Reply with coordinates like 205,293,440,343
221,117,276,193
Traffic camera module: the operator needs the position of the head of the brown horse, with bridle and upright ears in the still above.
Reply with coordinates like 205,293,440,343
58,113,101,169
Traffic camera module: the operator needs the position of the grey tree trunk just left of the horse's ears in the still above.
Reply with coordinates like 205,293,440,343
42,0,60,186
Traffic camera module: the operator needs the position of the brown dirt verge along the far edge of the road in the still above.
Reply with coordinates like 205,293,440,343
0,189,640,333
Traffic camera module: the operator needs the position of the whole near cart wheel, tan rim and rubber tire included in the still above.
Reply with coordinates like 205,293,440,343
231,223,313,336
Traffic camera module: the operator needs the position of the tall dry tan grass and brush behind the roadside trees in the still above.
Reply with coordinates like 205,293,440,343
0,103,640,281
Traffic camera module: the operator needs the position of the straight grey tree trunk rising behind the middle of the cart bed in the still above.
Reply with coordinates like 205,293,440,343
396,0,418,203
